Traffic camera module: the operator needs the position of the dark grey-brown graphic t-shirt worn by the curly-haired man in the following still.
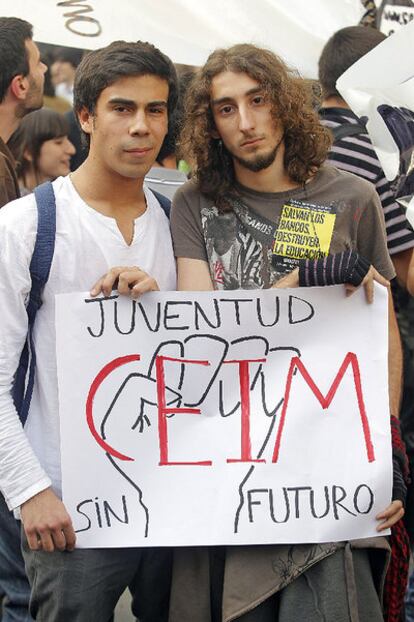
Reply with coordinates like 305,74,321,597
171,166,394,289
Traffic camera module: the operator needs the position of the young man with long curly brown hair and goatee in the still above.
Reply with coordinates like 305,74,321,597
170,44,403,622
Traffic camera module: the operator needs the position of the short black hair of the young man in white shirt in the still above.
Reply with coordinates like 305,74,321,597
73,41,178,145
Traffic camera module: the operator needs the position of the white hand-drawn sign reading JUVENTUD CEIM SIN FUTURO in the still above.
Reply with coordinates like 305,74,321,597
56,287,392,547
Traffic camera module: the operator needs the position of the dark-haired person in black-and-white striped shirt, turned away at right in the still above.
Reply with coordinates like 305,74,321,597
319,26,414,620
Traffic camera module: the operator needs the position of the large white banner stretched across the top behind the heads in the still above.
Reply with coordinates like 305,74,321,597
0,0,364,78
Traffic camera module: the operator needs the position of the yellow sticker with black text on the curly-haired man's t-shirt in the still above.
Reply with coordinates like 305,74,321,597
272,200,336,273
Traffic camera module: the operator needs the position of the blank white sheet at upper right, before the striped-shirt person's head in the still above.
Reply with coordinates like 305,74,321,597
336,21,414,180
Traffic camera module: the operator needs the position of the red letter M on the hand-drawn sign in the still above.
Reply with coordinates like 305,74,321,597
272,352,375,462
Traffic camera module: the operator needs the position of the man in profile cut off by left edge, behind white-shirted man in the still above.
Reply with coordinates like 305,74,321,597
0,17,46,622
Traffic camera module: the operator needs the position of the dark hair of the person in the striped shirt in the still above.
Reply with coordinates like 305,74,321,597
319,26,386,98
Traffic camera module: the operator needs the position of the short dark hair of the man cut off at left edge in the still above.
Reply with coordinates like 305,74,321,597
0,17,33,103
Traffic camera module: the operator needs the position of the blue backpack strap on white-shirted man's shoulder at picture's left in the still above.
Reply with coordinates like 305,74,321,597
13,181,56,425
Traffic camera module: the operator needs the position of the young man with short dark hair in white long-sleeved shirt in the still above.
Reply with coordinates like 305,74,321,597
0,41,177,622
